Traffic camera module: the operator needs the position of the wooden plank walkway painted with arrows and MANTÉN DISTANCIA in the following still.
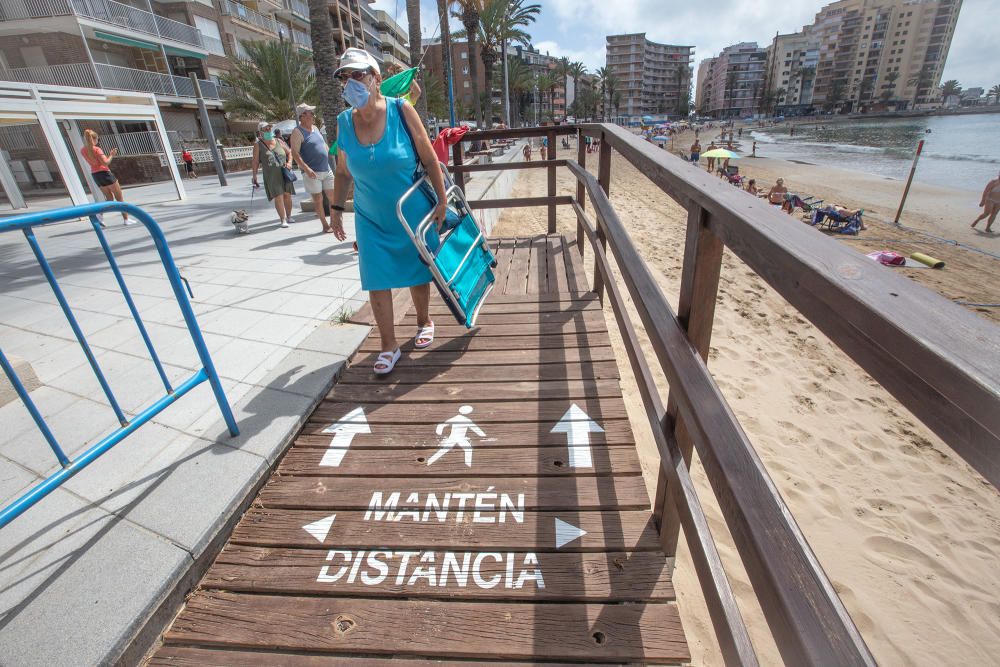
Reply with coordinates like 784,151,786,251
151,236,689,665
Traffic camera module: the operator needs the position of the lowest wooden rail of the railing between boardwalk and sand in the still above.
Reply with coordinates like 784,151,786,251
573,201,758,667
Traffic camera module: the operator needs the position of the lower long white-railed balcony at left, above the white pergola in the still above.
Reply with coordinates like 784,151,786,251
0,63,220,100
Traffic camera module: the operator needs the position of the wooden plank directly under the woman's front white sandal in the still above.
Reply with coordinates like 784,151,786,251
339,361,618,385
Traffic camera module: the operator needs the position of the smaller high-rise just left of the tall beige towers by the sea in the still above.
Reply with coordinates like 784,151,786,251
696,42,767,118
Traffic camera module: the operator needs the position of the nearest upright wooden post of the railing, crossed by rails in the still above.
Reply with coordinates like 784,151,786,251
653,204,723,556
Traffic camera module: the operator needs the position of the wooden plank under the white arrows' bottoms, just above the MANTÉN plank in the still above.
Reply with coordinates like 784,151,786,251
278,446,642,478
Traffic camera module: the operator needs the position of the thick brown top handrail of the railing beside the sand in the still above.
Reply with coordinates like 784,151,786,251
583,124,1000,488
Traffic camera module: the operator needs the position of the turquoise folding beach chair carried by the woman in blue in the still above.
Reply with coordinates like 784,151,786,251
396,164,497,329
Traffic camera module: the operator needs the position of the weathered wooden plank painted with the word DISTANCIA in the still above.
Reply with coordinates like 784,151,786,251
201,545,674,602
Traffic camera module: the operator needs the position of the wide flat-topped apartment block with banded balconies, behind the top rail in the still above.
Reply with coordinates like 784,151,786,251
607,33,694,117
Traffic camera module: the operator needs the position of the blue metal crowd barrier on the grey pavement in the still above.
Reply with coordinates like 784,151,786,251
0,202,239,528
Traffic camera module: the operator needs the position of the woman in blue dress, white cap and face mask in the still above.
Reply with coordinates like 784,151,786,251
330,48,447,375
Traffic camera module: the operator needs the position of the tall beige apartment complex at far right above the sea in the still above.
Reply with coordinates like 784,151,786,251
768,0,962,113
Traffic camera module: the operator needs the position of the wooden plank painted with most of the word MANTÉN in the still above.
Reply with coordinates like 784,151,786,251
257,474,649,517
